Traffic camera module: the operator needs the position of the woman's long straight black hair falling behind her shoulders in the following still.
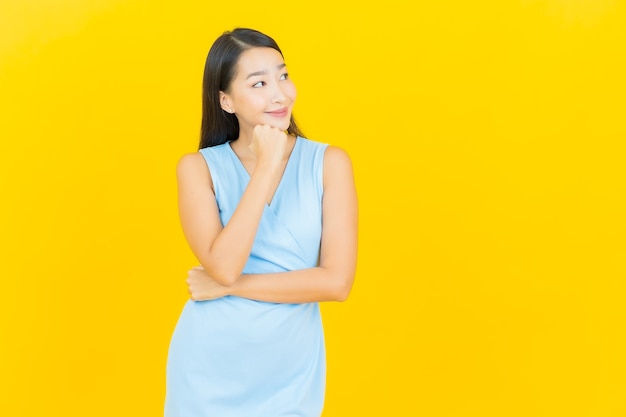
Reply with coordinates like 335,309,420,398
199,28,303,149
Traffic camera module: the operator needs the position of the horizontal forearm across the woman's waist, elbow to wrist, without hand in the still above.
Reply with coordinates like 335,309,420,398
227,267,354,303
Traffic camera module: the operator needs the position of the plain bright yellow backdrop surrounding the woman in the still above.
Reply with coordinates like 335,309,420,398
0,0,626,417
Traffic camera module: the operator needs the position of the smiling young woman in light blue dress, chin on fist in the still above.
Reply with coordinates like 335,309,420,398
165,29,357,417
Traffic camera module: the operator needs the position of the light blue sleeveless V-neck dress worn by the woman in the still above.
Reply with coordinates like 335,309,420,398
165,137,327,417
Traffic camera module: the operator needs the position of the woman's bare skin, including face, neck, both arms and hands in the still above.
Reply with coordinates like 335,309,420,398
177,48,358,303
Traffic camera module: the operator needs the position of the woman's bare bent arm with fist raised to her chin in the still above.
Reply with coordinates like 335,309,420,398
176,125,286,285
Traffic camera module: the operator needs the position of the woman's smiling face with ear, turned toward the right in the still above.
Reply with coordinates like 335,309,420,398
220,48,296,131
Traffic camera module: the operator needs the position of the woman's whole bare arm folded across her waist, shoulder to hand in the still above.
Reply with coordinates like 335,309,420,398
187,146,358,303
